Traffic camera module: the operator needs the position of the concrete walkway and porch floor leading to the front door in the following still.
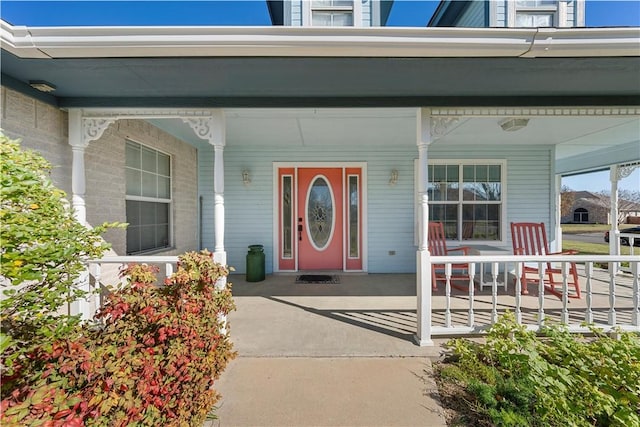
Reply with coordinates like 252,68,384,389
207,275,446,427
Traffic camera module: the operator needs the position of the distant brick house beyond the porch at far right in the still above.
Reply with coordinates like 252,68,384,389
561,191,640,224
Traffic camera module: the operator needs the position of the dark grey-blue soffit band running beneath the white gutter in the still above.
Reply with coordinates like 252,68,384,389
1,50,640,107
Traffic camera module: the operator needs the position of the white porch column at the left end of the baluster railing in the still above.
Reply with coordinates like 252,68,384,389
415,108,433,346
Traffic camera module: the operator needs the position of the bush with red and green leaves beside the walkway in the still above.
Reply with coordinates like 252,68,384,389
0,251,235,426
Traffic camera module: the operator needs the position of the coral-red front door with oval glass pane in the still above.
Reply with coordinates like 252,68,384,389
297,168,343,270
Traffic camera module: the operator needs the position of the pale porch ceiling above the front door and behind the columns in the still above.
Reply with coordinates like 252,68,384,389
150,108,640,173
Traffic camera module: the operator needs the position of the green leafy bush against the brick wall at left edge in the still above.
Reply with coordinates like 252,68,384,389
0,133,113,374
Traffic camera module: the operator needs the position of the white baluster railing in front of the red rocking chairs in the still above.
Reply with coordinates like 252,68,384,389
423,255,640,339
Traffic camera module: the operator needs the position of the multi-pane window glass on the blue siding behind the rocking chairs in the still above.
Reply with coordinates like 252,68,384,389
427,162,504,241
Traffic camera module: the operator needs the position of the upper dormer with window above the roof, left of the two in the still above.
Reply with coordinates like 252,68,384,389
267,0,393,27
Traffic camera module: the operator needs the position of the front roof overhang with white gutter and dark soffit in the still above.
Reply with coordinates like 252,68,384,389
0,22,640,108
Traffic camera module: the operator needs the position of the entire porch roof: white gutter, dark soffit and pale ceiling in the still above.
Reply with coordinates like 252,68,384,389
0,21,640,174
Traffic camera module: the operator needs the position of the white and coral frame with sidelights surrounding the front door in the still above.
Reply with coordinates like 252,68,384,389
271,161,369,273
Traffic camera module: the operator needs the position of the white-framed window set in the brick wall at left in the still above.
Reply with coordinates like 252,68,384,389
125,141,171,255
